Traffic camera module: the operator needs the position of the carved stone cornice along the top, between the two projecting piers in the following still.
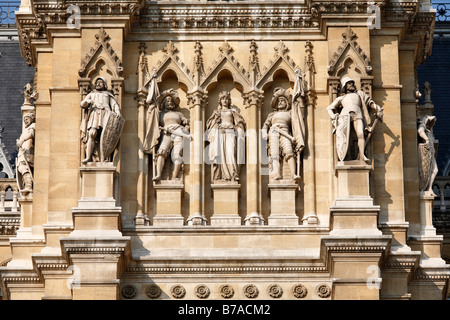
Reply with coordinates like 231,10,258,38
140,2,313,31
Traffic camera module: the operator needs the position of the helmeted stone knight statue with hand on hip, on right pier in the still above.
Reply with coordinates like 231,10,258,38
327,77,383,163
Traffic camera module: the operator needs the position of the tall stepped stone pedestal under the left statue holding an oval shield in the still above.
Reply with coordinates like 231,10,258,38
59,162,130,300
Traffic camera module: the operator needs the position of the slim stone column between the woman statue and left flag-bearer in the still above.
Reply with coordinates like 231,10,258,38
187,87,207,226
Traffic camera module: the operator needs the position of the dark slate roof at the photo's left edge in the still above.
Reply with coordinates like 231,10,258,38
0,36,34,167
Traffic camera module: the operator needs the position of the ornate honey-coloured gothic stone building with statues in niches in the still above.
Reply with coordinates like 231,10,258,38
0,0,450,300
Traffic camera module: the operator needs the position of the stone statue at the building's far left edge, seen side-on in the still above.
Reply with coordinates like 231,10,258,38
16,112,36,194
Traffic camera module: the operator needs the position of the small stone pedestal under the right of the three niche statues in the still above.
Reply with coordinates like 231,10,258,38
268,180,299,226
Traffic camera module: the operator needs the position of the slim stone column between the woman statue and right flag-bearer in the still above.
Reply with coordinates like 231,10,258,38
244,89,264,225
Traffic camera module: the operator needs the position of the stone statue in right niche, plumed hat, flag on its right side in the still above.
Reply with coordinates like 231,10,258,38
262,83,305,181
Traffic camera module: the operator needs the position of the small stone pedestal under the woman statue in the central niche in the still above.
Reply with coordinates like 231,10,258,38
211,183,242,226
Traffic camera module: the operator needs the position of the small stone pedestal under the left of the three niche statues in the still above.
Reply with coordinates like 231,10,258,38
153,181,184,227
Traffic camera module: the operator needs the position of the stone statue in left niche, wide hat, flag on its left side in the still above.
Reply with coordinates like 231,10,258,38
144,89,190,181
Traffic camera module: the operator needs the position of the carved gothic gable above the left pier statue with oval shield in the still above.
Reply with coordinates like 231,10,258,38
78,28,123,78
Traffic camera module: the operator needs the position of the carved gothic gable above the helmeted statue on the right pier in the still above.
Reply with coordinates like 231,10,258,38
328,27,372,76
